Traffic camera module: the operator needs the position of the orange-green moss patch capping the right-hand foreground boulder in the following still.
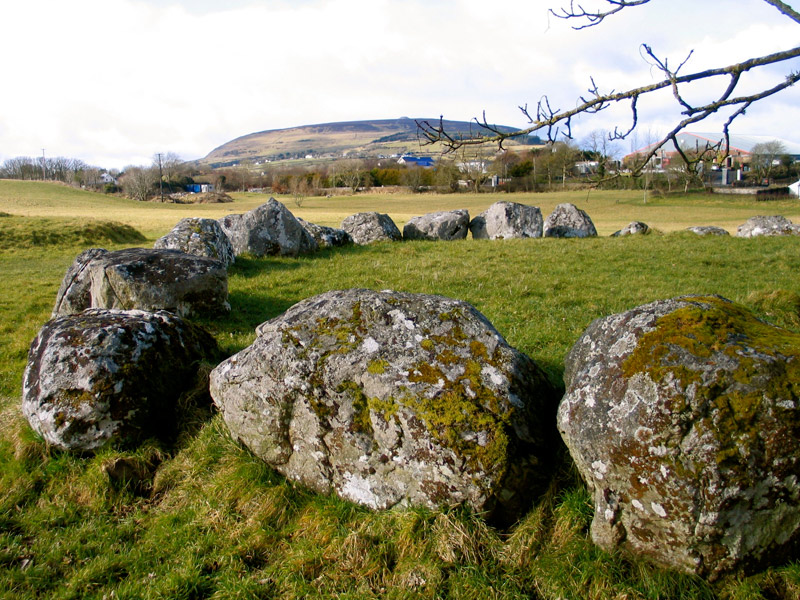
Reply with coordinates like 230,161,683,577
622,297,800,468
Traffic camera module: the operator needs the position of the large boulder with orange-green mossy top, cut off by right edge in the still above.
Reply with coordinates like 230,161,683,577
558,296,800,579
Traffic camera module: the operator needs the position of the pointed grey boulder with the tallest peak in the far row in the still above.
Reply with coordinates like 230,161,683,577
219,198,319,256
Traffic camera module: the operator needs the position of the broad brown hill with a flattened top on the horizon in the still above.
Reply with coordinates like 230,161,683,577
198,117,527,167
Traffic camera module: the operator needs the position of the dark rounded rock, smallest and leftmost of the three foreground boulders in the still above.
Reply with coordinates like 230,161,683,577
22,309,216,452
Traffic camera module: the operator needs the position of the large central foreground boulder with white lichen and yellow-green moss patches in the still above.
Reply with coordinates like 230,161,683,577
210,290,555,520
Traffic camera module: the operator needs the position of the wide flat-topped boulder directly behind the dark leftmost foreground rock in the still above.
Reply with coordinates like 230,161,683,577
52,248,230,317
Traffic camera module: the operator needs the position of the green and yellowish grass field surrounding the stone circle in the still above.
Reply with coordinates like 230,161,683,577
0,181,800,600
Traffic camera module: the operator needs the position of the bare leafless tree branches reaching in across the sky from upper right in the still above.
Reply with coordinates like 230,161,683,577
417,0,800,174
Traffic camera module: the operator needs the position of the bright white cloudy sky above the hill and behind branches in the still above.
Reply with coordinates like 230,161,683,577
0,0,800,169
